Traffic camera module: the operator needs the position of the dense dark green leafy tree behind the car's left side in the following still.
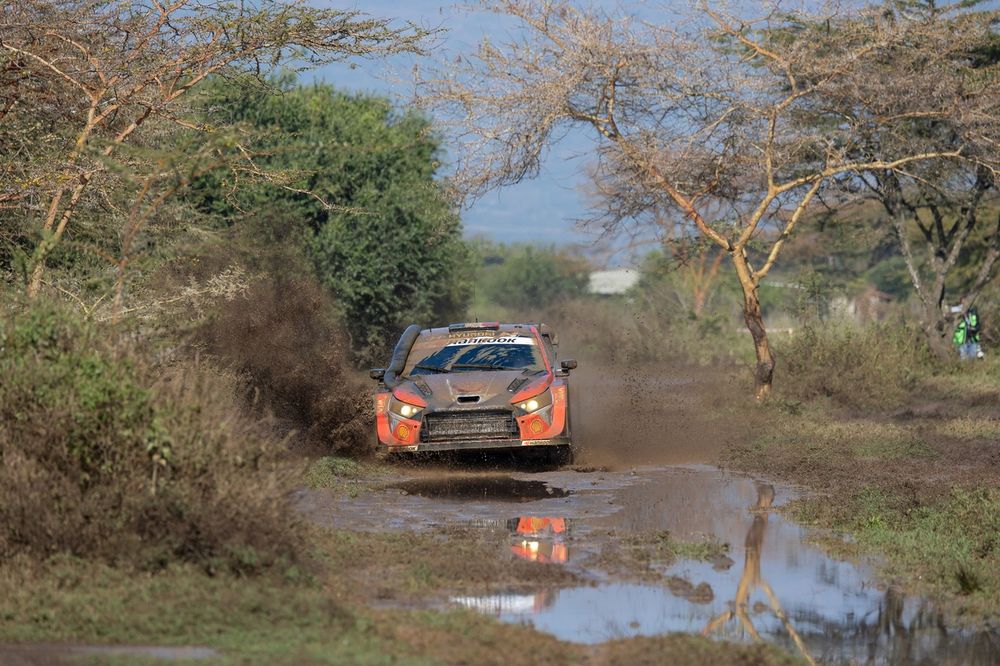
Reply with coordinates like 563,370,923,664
194,79,470,361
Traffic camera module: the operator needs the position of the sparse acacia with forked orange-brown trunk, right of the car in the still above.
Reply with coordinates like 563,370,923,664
418,0,984,399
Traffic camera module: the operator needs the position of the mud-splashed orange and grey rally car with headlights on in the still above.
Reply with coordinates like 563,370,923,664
370,323,576,460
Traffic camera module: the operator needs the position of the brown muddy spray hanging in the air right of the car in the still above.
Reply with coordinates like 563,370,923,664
552,307,748,469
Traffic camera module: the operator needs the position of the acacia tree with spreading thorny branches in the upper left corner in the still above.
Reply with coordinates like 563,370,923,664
0,0,426,296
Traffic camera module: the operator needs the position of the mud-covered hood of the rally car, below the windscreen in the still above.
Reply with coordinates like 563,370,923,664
399,370,546,409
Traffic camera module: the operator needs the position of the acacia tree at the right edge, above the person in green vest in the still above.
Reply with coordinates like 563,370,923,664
808,0,1000,356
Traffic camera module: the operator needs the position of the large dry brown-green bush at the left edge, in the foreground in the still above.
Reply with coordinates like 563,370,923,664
0,304,299,573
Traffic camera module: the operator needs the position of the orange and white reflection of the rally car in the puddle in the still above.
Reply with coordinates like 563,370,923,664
451,516,569,617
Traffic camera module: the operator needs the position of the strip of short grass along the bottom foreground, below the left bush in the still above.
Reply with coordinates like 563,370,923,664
0,532,789,666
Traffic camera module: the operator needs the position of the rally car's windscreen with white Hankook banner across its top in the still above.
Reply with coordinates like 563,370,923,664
403,333,545,376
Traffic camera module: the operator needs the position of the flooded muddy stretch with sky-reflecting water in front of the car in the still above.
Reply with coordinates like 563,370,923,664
300,466,1000,664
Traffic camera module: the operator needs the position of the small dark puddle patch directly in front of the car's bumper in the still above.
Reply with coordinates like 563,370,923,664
390,476,569,502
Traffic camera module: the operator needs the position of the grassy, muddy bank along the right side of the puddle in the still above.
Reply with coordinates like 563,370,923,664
723,378,1000,624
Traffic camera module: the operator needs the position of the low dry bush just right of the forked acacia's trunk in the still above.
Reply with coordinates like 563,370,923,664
775,323,933,409
